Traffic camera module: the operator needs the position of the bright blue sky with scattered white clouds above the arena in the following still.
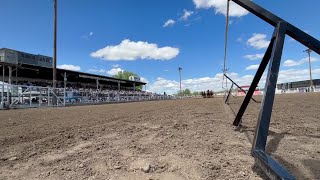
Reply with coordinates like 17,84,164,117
0,0,320,93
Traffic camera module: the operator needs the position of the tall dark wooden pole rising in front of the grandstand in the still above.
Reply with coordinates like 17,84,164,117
52,0,57,88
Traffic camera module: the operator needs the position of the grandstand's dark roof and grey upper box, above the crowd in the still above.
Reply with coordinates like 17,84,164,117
0,48,146,90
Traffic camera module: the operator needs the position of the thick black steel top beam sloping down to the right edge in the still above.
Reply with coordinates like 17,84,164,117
232,0,320,55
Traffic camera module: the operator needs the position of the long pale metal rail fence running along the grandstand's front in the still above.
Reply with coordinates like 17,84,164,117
0,84,173,109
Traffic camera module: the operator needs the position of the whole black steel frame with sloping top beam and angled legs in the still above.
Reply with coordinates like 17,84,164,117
228,0,320,179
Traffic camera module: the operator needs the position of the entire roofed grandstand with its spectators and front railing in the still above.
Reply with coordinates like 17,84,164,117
0,48,168,108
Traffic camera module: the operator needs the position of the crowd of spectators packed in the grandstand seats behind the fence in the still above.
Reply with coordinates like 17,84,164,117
2,81,172,104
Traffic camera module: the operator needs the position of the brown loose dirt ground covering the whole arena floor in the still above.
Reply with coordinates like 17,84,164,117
0,94,320,180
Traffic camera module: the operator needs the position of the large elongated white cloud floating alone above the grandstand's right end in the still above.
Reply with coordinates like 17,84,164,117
91,39,179,61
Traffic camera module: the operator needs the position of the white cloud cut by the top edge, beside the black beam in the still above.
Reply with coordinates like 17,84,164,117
193,0,249,17
